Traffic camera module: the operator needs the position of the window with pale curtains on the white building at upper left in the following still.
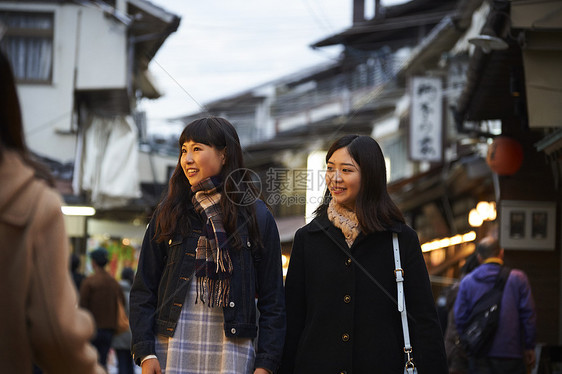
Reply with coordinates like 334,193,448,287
0,12,54,83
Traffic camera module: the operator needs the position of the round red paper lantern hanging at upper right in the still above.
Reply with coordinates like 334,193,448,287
486,136,523,175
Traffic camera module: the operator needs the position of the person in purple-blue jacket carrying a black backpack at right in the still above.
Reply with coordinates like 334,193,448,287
454,237,536,374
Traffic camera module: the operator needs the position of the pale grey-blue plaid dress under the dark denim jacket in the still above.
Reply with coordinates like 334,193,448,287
156,277,255,374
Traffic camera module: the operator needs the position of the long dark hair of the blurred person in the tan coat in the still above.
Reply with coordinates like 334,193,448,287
0,50,54,186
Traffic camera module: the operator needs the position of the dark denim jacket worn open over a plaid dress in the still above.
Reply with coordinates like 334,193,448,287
130,200,285,371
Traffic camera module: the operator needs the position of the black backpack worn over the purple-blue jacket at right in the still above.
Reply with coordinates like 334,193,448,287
459,266,511,357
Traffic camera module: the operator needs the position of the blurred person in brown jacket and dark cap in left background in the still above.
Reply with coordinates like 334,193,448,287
80,247,125,368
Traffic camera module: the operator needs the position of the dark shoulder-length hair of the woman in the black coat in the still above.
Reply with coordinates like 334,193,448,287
315,135,404,233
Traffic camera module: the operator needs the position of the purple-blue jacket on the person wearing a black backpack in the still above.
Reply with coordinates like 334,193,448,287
455,263,536,358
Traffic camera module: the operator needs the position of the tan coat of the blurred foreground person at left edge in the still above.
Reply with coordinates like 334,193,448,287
0,151,104,374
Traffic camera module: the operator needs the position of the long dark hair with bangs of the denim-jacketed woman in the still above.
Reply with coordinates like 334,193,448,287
151,117,261,248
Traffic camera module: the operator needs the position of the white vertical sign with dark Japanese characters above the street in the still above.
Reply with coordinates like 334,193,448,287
410,77,443,162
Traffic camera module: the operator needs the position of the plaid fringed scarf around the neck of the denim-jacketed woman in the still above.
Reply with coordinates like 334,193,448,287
191,176,232,307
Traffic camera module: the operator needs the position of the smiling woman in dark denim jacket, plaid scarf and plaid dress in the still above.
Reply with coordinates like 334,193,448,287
130,117,285,374
